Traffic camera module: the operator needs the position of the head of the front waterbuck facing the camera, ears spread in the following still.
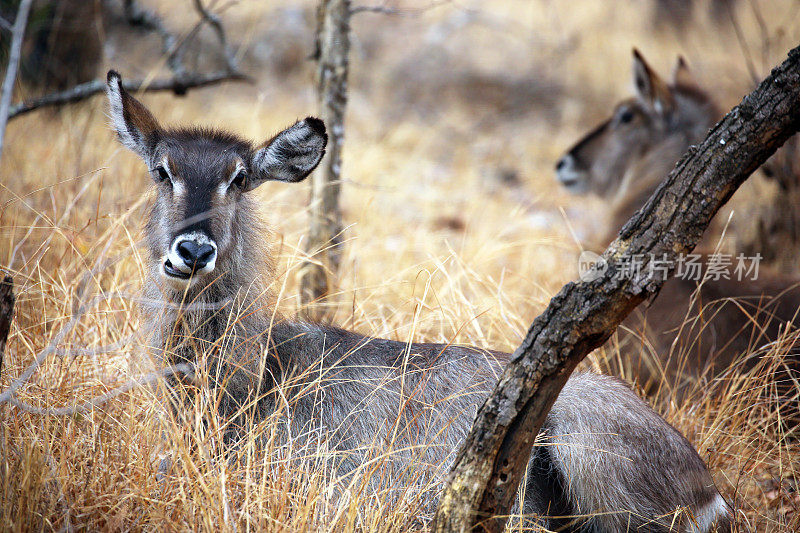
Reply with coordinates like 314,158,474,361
107,70,328,290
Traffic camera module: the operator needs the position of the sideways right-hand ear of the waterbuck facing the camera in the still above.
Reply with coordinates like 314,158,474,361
249,117,328,189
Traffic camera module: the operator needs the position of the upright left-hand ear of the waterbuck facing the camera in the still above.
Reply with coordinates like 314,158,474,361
106,70,161,159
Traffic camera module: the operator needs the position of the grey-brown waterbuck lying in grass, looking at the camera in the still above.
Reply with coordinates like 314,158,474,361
108,71,730,532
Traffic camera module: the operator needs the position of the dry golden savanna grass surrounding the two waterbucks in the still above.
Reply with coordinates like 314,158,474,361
0,0,800,532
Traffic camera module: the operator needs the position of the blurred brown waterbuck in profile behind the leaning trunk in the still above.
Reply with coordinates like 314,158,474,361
556,50,800,408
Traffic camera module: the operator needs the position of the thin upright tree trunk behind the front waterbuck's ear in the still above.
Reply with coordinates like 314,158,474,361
300,0,351,319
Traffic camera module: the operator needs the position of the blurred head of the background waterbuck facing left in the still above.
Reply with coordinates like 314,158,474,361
556,50,720,197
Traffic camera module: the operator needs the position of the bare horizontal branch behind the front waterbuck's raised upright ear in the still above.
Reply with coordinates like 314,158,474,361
9,71,252,119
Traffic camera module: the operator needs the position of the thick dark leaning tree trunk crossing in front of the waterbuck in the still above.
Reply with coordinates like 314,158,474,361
434,48,800,532
